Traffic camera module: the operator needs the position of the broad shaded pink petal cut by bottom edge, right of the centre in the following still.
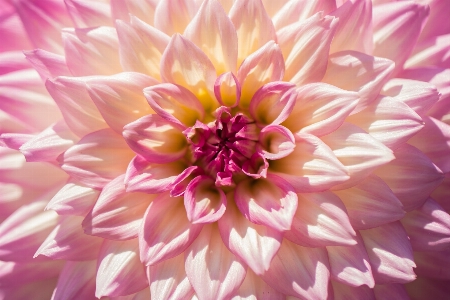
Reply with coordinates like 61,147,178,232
261,239,330,300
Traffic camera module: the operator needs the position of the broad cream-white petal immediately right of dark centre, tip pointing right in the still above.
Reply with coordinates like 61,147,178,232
269,133,349,193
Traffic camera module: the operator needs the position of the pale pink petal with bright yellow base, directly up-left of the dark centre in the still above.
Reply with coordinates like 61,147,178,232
161,34,217,111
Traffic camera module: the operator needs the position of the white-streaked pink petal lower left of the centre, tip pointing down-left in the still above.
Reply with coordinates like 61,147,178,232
81,175,155,240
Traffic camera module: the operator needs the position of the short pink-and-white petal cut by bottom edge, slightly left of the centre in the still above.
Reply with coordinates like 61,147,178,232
148,254,194,300
